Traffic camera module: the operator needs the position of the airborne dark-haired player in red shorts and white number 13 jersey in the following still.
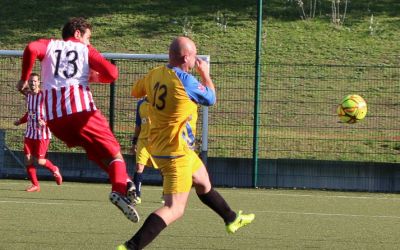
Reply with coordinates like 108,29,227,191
17,17,139,222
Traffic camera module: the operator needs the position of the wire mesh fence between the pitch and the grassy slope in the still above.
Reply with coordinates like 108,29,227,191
0,51,400,166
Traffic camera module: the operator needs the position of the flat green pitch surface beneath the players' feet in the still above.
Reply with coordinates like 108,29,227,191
0,180,400,250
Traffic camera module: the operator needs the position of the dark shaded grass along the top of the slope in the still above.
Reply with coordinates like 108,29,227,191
0,0,400,47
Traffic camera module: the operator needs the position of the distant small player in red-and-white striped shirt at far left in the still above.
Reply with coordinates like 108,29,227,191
14,73,62,192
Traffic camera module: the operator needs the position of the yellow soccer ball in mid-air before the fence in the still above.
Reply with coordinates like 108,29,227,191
337,95,367,123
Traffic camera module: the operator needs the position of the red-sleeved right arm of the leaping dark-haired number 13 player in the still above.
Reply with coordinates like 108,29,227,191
88,46,118,83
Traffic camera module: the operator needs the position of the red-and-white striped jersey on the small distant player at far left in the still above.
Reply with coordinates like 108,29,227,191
19,91,51,140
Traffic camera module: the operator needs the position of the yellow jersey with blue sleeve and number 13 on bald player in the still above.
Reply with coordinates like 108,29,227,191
131,66,216,158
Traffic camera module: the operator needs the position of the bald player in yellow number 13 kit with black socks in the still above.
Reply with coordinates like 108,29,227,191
117,37,255,249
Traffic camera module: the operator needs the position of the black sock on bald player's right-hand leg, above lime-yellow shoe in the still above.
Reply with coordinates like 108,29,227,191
197,188,236,224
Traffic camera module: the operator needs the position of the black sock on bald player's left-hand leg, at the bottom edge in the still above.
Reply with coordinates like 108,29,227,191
125,213,167,250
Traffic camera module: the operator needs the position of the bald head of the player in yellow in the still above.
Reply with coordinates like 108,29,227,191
169,36,197,71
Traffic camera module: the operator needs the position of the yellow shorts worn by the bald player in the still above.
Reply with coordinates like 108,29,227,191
153,150,203,194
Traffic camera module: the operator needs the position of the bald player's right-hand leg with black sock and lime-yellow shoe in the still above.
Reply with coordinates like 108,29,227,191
192,150,255,233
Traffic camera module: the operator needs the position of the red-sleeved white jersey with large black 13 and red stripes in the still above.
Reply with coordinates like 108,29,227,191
21,38,118,120
